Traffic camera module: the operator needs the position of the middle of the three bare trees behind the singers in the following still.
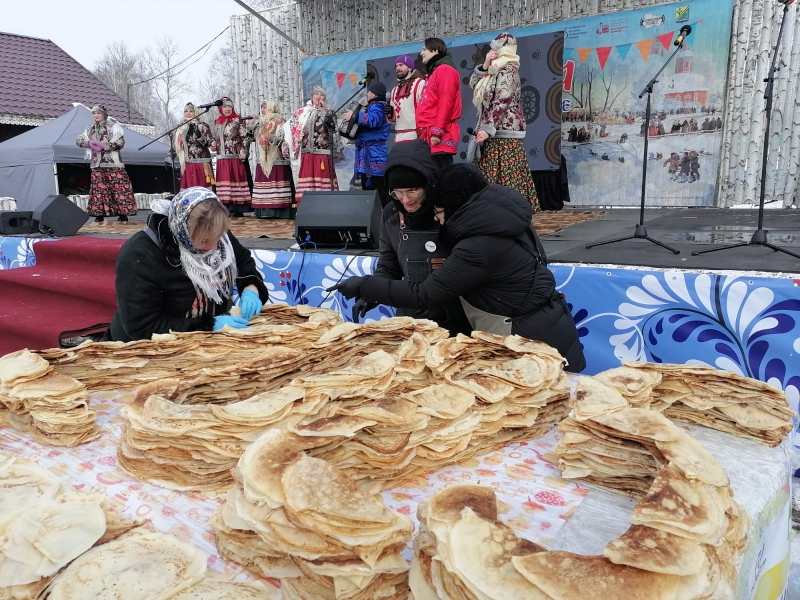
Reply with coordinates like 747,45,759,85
144,36,191,141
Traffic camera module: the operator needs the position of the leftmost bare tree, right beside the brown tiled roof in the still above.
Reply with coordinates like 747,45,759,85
92,41,153,122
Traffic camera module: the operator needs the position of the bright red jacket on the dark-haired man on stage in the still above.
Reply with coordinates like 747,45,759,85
417,63,461,154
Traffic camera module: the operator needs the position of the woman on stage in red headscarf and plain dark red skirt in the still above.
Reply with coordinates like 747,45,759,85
215,96,252,217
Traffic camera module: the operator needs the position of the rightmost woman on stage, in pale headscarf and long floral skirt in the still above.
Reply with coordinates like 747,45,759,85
469,33,540,211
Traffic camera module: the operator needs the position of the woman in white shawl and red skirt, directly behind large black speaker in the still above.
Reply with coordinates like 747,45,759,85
289,85,339,205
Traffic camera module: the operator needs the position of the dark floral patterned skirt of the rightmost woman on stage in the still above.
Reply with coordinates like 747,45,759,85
478,138,541,211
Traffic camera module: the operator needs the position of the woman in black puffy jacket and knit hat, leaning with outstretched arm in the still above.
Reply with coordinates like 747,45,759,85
331,164,586,372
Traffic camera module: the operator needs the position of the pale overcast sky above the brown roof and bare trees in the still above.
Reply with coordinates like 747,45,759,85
0,0,245,103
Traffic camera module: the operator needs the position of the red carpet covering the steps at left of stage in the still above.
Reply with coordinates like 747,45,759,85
0,237,125,355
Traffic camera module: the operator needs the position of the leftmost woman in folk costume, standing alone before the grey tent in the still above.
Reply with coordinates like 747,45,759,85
75,104,136,222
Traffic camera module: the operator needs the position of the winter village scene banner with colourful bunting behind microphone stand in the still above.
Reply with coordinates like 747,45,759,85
561,0,733,206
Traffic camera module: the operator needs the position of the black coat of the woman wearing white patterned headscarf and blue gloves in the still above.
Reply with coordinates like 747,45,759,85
106,214,269,342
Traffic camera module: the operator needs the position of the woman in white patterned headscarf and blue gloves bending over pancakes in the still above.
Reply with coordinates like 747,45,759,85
106,187,269,342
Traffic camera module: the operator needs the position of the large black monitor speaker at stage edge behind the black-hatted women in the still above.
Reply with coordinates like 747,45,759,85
294,191,382,249
